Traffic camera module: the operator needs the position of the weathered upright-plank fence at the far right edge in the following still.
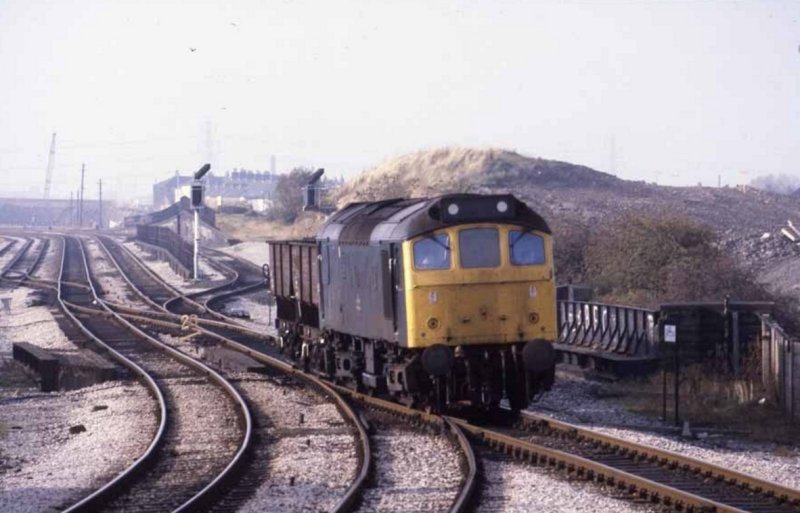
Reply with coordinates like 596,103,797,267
761,315,800,420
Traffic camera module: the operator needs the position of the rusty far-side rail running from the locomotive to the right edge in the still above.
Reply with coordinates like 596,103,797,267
523,412,800,508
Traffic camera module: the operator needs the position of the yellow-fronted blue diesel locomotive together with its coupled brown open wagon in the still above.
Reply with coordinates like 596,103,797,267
270,194,557,411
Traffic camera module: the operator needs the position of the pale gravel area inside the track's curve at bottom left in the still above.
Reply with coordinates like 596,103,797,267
0,382,156,513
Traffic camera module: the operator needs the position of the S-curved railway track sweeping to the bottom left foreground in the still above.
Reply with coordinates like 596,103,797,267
59,237,252,512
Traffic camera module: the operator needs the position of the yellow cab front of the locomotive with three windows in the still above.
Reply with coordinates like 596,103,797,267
403,223,557,348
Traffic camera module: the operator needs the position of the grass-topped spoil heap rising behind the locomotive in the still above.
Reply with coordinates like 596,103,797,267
336,148,800,292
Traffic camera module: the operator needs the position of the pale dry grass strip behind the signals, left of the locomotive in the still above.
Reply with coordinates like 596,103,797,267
217,212,324,241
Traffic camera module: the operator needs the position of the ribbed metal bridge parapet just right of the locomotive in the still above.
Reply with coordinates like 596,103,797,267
558,301,659,358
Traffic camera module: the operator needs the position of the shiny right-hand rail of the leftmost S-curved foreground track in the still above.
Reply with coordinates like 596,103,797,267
64,235,253,513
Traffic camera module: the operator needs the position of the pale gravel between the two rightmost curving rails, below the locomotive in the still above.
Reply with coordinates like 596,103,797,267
358,416,463,513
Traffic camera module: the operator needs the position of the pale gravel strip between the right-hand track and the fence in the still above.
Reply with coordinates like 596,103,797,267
531,375,800,488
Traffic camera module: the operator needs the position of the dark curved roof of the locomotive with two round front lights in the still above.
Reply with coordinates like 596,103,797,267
317,194,551,244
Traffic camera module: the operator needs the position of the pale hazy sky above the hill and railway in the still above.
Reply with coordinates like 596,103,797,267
0,0,800,202
